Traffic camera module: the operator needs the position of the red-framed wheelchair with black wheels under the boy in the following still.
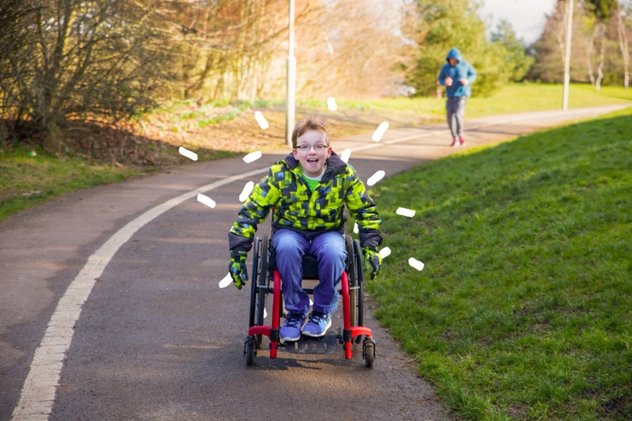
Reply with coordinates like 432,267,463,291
244,234,375,368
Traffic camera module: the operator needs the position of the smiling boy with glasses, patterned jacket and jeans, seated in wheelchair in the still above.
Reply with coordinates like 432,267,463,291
228,118,382,341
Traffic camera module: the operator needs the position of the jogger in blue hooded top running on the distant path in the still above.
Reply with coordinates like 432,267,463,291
438,48,476,147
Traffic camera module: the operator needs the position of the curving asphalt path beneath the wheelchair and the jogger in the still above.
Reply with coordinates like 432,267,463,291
0,103,622,420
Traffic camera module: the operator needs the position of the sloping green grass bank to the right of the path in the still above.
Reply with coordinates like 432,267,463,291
369,109,632,420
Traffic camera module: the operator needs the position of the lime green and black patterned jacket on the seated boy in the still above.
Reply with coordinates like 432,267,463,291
228,153,382,251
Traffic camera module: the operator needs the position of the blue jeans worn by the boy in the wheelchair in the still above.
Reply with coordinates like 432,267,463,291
272,229,347,315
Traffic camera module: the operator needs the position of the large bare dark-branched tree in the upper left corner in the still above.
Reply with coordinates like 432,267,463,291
3,0,170,151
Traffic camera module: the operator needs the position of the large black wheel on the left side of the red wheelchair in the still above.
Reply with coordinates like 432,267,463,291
249,236,269,348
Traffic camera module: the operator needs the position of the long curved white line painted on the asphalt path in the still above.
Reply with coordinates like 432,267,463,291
13,167,268,421
